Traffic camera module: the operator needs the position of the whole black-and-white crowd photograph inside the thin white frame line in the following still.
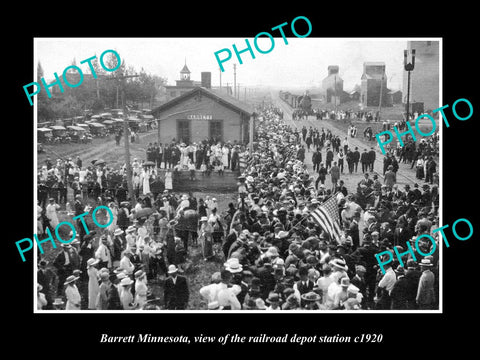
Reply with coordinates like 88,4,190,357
31,37,440,314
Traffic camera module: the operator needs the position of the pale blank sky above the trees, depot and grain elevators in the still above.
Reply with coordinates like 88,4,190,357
34,37,420,91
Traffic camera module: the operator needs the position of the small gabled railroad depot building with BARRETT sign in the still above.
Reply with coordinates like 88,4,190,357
152,85,254,144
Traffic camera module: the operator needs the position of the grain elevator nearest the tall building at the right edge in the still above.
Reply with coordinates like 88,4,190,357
360,62,388,106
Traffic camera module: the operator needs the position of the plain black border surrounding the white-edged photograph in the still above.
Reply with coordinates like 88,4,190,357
8,7,479,357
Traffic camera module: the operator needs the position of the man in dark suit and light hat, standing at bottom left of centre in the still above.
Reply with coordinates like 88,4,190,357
164,264,190,310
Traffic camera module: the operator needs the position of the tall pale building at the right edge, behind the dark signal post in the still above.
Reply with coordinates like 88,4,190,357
403,41,440,112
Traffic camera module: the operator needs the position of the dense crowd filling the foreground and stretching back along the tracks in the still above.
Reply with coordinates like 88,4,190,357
38,102,439,310
